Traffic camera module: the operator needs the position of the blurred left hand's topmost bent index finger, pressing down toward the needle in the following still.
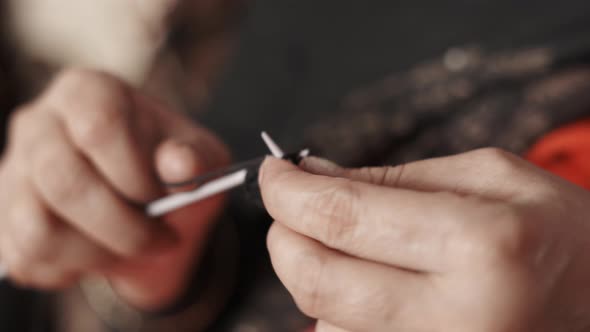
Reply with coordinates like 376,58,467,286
40,69,160,203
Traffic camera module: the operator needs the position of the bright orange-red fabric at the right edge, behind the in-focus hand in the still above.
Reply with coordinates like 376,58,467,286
526,118,590,189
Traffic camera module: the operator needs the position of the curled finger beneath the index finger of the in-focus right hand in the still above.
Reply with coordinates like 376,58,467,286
268,223,430,331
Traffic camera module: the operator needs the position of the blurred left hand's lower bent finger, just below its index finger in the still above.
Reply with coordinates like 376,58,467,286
31,113,174,257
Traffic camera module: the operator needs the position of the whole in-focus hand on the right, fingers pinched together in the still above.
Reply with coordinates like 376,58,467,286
260,149,590,332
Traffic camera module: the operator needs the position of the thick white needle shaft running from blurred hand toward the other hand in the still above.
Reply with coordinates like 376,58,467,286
146,169,248,217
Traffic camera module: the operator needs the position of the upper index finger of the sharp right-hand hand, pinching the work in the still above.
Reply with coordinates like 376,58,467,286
260,158,498,271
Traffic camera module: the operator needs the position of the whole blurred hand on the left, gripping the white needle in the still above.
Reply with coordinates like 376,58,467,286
0,70,229,309
